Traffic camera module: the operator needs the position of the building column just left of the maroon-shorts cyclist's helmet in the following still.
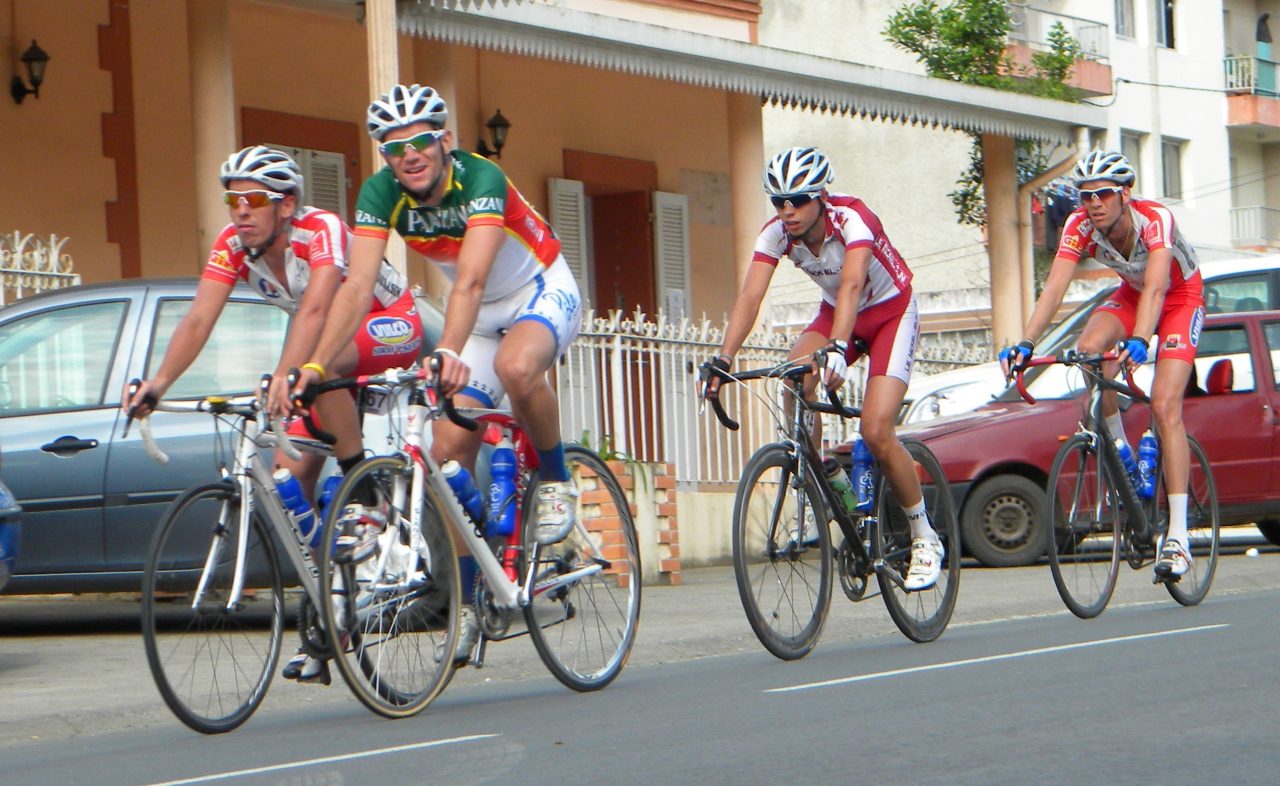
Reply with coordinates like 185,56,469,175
728,92,765,288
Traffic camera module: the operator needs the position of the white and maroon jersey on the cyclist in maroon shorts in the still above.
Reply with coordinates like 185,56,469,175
751,193,911,311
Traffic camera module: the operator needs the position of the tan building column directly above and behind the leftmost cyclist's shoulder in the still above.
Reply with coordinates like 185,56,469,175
187,0,239,261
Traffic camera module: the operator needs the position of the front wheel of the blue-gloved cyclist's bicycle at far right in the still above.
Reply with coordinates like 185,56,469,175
1047,434,1121,620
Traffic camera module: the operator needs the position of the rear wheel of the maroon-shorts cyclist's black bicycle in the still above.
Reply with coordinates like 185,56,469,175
872,439,960,643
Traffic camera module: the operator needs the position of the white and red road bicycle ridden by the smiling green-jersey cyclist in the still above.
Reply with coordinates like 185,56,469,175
296,360,641,717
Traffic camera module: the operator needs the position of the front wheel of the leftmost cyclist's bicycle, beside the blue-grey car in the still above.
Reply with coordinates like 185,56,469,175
142,483,284,734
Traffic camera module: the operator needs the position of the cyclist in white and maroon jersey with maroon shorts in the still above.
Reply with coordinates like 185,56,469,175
703,147,945,590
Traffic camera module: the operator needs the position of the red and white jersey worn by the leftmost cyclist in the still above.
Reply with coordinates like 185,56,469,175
202,207,408,314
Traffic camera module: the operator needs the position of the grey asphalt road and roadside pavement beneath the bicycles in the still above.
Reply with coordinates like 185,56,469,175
0,548,1280,786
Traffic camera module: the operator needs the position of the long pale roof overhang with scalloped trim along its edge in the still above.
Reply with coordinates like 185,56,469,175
398,0,1106,145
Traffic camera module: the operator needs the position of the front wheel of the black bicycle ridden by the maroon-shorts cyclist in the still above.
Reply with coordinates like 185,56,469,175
733,444,832,661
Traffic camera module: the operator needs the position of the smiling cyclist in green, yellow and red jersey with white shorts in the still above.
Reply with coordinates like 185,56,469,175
301,84,581,661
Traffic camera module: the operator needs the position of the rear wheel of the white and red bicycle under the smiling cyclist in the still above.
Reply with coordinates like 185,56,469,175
521,445,641,691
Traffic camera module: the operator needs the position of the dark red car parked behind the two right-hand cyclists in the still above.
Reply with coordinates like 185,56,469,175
899,311,1280,566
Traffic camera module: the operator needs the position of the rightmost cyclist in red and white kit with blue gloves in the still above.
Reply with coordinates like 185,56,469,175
1000,150,1204,580
